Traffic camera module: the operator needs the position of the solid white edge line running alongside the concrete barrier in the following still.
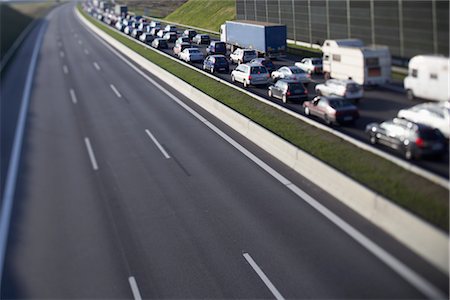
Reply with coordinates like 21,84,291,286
77,15,447,299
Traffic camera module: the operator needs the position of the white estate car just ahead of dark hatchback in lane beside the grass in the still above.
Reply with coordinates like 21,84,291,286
231,63,270,87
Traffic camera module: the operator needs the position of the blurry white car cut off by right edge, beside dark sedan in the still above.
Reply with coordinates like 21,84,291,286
397,103,450,139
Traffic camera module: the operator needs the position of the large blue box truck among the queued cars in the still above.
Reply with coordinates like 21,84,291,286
220,21,287,58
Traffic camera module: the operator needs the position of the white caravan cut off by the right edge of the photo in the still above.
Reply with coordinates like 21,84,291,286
404,55,450,101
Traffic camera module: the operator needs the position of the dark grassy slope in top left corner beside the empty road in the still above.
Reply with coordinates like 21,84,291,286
0,1,54,60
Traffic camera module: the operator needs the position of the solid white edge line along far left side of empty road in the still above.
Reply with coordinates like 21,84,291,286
0,23,47,290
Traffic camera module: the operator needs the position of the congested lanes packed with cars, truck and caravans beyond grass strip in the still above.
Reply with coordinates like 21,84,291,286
85,5,450,178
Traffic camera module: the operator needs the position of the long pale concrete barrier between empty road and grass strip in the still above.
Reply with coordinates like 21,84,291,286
76,11,449,274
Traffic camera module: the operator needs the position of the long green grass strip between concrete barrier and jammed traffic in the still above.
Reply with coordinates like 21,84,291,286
78,6,449,231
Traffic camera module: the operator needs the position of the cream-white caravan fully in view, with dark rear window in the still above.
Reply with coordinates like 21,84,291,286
322,39,391,85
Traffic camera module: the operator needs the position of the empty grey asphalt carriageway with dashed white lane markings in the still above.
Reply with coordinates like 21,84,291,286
0,4,448,299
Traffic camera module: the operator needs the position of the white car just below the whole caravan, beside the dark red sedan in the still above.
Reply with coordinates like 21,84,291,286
316,79,364,101
